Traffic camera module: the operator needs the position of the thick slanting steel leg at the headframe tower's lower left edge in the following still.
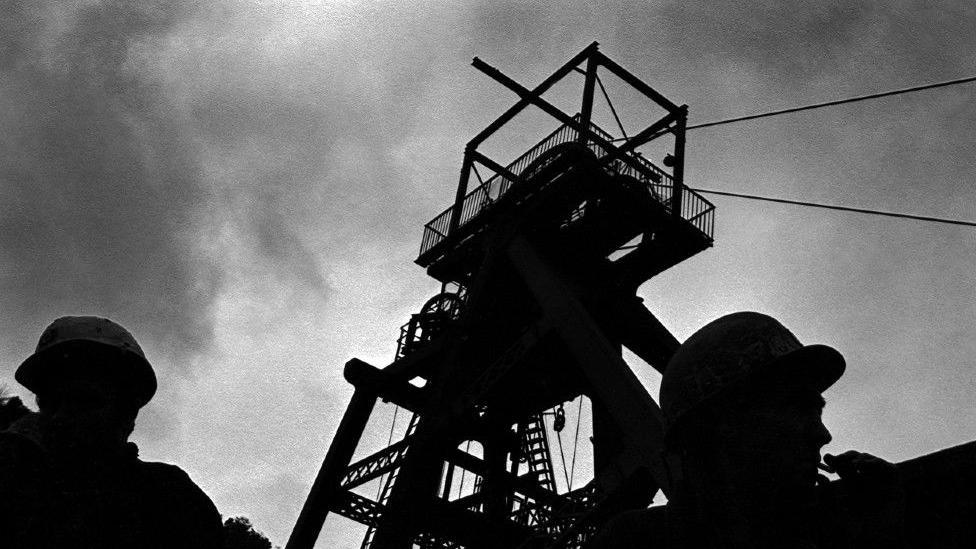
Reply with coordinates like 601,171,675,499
285,388,376,549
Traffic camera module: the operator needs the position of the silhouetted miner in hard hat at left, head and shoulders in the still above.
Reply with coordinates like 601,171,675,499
0,317,222,549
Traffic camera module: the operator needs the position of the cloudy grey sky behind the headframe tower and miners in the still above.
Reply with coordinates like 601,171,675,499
0,0,976,548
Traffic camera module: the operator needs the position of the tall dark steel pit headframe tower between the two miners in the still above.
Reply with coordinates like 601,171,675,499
287,43,714,549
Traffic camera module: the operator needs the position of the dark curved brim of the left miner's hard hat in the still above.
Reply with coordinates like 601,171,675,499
14,339,157,408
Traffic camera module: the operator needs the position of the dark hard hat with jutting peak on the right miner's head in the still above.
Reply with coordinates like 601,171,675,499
660,312,845,440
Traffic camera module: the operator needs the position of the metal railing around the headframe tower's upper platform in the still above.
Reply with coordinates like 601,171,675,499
420,115,715,256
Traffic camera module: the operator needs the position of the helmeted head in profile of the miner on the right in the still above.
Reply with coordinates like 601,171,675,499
660,312,845,546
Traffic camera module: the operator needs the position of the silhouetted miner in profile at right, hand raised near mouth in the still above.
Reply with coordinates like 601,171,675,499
589,312,904,549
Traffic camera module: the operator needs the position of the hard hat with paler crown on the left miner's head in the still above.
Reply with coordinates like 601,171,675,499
14,316,156,408
